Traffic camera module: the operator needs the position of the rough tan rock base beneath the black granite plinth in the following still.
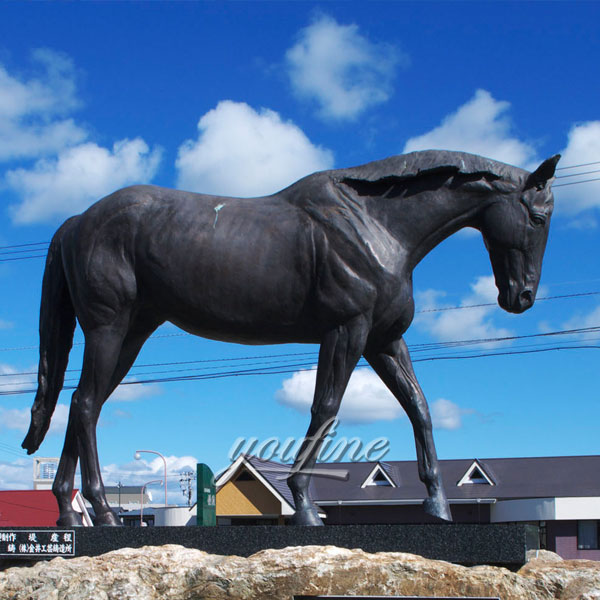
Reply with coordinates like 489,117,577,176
0,545,600,600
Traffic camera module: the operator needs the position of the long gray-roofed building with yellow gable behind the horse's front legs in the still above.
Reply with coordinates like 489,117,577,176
216,455,600,560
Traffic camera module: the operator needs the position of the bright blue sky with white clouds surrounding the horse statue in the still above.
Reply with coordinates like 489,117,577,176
0,2,600,501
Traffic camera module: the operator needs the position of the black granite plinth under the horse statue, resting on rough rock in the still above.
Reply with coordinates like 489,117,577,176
0,524,539,568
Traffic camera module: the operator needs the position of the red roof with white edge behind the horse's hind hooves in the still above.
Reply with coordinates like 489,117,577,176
0,490,92,527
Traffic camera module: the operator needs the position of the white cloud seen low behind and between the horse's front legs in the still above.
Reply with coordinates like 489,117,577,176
275,369,404,423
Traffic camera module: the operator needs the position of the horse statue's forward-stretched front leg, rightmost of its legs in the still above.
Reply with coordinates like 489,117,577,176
365,338,452,521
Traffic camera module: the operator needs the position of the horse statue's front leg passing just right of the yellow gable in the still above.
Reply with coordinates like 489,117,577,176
287,317,368,525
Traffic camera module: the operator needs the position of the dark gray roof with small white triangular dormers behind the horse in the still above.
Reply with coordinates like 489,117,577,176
241,456,600,506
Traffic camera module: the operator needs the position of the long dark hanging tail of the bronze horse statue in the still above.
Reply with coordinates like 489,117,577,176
21,219,75,454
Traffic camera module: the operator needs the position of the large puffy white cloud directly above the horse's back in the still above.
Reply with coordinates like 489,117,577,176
176,100,333,196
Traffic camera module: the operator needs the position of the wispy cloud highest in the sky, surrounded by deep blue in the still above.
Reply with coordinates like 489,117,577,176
286,16,406,119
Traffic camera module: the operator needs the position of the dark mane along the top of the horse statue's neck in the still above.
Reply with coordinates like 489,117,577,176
328,150,529,185
